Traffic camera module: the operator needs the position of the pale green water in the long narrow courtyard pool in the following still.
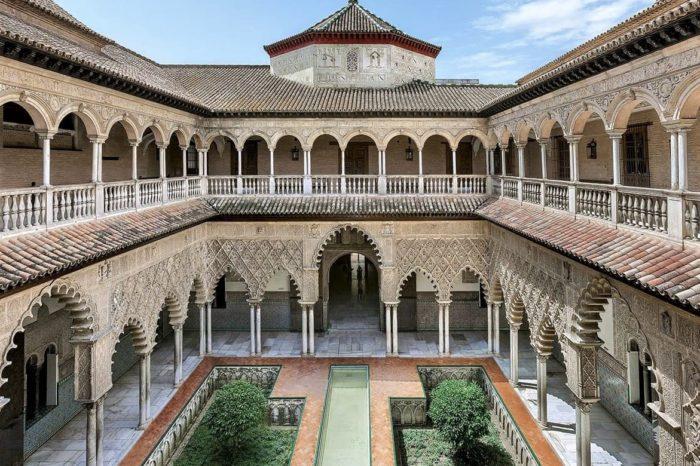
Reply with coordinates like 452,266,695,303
316,367,371,466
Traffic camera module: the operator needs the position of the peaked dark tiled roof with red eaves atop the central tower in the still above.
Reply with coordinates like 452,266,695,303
265,0,441,58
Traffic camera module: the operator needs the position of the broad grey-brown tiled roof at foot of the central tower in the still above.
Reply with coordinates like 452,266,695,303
165,65,511,115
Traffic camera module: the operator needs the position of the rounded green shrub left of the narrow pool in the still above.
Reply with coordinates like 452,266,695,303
203,381,267,454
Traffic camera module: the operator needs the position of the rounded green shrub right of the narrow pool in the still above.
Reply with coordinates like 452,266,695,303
428,380,490,457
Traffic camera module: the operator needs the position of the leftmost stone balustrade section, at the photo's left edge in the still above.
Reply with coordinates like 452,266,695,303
0,188,46,234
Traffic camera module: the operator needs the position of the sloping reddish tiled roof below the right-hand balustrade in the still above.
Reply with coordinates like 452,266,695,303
477,199,700,313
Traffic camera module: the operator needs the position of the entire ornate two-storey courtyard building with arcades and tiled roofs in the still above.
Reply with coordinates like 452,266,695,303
0,0,700,466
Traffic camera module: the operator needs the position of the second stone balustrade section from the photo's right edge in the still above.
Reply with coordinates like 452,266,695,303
617,187,668,233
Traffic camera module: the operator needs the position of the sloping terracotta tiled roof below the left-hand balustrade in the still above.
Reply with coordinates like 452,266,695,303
0,200,216,293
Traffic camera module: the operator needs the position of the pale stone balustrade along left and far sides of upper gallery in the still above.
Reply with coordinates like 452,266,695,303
0,175,488,237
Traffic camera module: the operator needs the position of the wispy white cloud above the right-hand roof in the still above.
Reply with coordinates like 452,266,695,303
474,0,651,44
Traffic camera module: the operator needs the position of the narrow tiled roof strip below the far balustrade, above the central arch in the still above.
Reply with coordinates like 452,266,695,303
210,195,488,218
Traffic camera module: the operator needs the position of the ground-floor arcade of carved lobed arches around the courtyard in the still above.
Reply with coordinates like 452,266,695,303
0,220,700,464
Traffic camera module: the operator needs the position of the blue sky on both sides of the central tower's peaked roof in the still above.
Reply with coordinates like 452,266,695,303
56,0,653,84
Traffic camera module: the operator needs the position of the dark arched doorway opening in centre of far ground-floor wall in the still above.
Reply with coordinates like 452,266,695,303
328,253,380,330
